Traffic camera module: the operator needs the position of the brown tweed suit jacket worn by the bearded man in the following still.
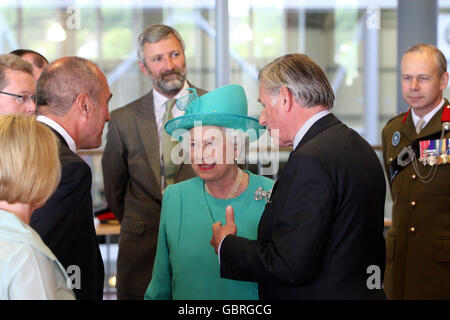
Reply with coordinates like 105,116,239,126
102,86,205,299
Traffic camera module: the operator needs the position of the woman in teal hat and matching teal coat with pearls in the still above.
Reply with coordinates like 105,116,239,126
145,85,273,300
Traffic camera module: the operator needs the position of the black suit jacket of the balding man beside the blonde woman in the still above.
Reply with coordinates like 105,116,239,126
30,130,105,300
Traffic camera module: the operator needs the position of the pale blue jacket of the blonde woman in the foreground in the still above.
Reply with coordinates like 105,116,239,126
0,210,75,300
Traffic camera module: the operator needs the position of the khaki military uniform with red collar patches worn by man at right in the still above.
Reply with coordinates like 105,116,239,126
382,100,450,299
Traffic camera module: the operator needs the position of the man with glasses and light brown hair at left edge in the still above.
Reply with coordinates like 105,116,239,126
0,54,36,115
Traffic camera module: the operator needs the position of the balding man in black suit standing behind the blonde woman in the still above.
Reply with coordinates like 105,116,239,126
30,57,112,299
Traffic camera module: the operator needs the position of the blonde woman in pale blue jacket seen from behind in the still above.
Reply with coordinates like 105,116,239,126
0,115,75,300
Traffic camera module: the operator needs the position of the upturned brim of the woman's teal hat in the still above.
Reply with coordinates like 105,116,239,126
164,112,266,141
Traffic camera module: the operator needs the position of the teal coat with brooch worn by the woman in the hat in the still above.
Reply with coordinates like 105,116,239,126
145,171,273,300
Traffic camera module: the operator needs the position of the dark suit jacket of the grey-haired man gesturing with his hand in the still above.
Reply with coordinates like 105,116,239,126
220,114,386,299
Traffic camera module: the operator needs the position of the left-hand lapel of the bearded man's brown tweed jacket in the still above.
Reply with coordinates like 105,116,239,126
135,90,161,187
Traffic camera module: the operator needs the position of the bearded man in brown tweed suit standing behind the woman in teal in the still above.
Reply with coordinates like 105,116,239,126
102,25,205,299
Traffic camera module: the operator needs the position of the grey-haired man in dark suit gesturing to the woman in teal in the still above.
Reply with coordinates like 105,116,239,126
211,54,386,299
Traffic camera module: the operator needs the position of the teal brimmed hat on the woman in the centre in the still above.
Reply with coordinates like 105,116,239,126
164,84,265,141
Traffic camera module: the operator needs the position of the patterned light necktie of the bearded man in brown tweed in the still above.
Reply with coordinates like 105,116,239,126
161,99,178,188
